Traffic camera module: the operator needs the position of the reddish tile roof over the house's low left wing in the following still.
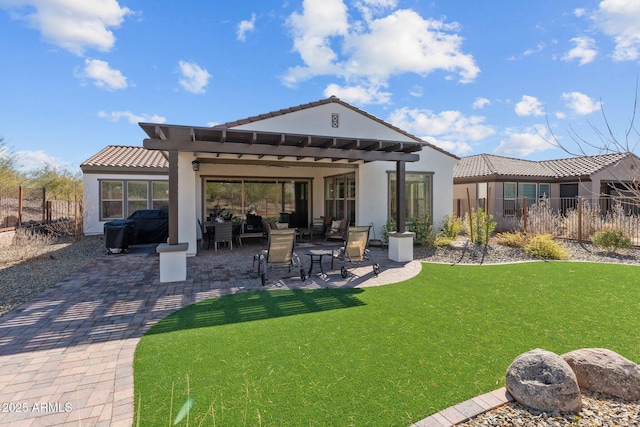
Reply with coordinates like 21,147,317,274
80,145,169,170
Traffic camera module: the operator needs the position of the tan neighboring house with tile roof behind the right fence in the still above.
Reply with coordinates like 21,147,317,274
453,153,640,228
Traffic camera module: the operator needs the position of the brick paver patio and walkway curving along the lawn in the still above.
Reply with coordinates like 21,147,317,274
0,243,421,427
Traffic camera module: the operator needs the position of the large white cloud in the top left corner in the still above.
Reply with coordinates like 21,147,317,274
0,0,132,55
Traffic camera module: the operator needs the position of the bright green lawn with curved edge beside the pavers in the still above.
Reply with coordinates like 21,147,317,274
134,263,640,427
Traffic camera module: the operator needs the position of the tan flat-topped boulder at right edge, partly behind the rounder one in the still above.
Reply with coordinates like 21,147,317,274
562,348,640,400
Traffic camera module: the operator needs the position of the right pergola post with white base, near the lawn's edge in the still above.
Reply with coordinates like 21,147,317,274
389,160,415,262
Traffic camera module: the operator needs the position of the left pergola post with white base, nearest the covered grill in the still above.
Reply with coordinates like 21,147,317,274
156,150,189,283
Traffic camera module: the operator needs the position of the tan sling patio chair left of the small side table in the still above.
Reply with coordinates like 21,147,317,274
254,228,307,286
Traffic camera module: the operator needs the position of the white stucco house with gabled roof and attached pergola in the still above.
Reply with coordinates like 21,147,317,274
81,97,459,255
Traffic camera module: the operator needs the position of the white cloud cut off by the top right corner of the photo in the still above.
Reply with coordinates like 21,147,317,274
592,0,640,61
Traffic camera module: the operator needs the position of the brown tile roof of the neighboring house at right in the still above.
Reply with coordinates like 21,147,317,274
453,153,629,179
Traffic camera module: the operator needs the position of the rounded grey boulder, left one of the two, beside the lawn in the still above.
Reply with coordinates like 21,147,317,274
506,349,582,414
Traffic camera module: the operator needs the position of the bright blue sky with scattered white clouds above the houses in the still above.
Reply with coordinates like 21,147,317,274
0,0,640,172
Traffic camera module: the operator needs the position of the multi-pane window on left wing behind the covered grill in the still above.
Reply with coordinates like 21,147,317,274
100,180,169,221
